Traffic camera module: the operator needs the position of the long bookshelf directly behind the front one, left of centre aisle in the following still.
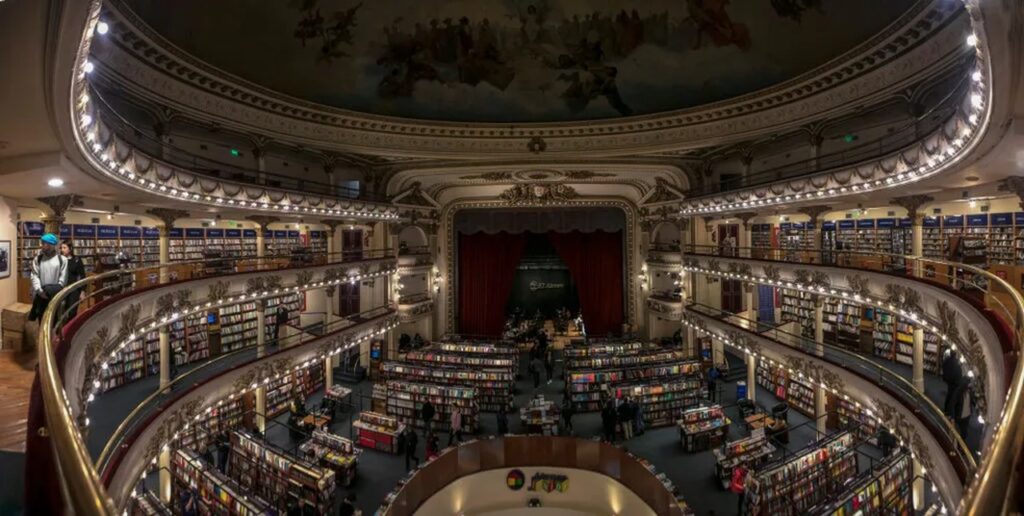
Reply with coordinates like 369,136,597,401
380,361,515,413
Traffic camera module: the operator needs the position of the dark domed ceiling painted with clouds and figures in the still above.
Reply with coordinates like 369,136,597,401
124,0,914,123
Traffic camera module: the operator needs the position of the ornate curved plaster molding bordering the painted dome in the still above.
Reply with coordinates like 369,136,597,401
99,0,963,156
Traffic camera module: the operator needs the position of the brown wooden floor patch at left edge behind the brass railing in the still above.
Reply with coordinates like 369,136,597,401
0,352,36,453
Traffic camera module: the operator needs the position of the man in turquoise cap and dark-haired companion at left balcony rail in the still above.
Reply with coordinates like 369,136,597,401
29,233,85,320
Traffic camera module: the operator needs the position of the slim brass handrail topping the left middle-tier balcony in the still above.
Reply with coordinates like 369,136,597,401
37,249,393,516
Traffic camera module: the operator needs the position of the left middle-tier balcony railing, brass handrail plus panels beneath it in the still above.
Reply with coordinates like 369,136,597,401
32,249,394,516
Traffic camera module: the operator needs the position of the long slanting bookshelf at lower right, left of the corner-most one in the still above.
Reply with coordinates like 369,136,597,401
746,432,857,516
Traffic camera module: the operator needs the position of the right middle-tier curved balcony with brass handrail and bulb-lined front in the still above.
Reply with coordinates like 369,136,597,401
684,246,1024,512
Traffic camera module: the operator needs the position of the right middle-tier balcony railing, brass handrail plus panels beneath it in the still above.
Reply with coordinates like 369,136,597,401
681,245,1024,514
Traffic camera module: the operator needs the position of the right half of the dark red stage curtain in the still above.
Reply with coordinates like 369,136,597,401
548,231,624,336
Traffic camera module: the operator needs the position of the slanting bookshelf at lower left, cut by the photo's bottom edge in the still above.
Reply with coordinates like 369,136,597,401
171,449,271,515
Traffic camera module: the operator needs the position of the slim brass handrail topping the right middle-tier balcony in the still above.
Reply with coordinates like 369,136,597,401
682,245,1024,515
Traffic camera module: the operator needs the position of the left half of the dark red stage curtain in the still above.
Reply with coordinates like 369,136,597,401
459,232,526,336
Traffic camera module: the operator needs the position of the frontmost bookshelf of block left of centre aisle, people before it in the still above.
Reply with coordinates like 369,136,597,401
373,380,477,433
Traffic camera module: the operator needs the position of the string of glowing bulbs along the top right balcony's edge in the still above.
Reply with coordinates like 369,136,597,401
680,34,985,215
